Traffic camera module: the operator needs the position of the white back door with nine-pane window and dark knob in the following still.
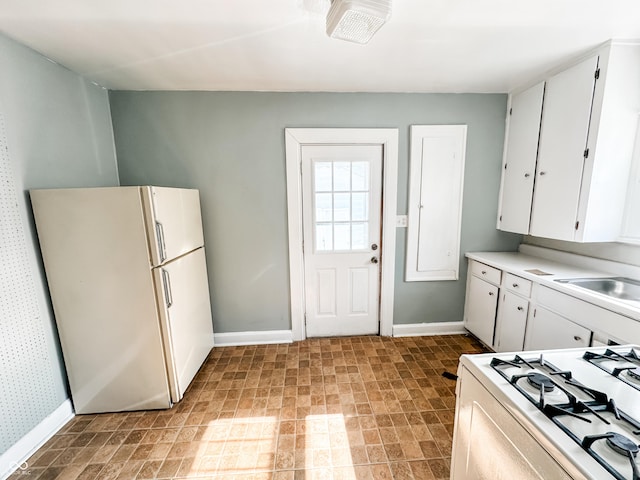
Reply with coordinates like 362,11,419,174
302,145,382,337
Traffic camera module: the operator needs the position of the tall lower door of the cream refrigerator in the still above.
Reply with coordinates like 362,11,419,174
153,248,213,402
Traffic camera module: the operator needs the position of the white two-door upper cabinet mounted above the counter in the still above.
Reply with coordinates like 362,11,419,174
498,42,640,242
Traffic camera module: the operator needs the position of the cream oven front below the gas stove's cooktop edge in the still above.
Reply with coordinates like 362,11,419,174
451,367,582,480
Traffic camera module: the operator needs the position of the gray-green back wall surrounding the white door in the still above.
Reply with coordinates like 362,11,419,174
110,91,521,333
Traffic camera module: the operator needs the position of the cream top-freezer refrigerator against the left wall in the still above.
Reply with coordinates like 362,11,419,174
30,186,213,414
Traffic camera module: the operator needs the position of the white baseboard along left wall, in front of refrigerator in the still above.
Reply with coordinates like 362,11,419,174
0,399,74,480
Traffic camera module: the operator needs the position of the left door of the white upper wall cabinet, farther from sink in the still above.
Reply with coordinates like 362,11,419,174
498,82,544,234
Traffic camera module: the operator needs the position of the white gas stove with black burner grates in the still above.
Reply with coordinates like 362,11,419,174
451,345,640,480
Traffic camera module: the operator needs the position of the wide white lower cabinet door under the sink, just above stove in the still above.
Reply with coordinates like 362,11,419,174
524,307,591,350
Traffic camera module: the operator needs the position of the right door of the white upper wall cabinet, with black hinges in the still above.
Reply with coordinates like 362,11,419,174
529,56,598,240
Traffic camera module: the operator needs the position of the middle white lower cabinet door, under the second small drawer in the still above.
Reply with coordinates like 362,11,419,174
494,292,529,352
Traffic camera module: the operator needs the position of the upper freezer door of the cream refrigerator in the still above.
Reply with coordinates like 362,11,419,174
141,187,204,266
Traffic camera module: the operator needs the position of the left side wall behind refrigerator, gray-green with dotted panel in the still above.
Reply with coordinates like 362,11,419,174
0,35,118,454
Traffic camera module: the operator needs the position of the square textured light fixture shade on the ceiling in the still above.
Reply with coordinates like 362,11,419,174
327,0,391,44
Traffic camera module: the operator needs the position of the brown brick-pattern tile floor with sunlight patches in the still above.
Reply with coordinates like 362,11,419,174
10,335,482,480
